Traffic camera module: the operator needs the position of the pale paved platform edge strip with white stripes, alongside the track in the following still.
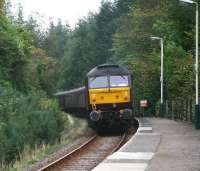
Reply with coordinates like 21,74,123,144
93,118,160,171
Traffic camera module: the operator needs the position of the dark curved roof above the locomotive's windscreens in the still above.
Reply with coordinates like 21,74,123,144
87,64,130,77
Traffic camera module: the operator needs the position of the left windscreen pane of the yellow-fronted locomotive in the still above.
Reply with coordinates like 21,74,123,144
89,76,108,88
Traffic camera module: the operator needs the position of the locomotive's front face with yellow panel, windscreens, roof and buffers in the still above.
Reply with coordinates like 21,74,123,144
87,64,133,122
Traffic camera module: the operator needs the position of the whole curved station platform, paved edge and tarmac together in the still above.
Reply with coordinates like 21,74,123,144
93,118,200,171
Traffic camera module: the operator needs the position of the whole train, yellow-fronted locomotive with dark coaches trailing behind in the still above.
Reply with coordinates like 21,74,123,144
56,64,134,128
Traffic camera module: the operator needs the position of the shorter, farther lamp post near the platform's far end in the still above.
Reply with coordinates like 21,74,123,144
151,36,164,116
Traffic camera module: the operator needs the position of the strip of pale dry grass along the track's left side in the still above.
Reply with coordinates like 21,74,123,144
5,115,87,171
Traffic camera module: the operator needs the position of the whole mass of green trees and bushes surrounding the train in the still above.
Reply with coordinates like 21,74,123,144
0,0,199,168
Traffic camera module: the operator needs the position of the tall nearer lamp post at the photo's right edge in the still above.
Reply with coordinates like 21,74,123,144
180,0,200,129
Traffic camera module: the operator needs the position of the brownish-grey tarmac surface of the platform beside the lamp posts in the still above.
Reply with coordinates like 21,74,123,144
147,118,200,171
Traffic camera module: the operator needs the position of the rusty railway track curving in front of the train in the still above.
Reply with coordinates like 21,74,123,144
39,134,127,171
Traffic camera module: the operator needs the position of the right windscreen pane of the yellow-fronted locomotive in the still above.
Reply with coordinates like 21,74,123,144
110,75,128,87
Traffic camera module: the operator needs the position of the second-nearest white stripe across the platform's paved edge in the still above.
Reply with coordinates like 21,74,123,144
107,152,154,160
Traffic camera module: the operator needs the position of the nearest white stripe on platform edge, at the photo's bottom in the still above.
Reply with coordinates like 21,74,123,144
92,163,148,171
